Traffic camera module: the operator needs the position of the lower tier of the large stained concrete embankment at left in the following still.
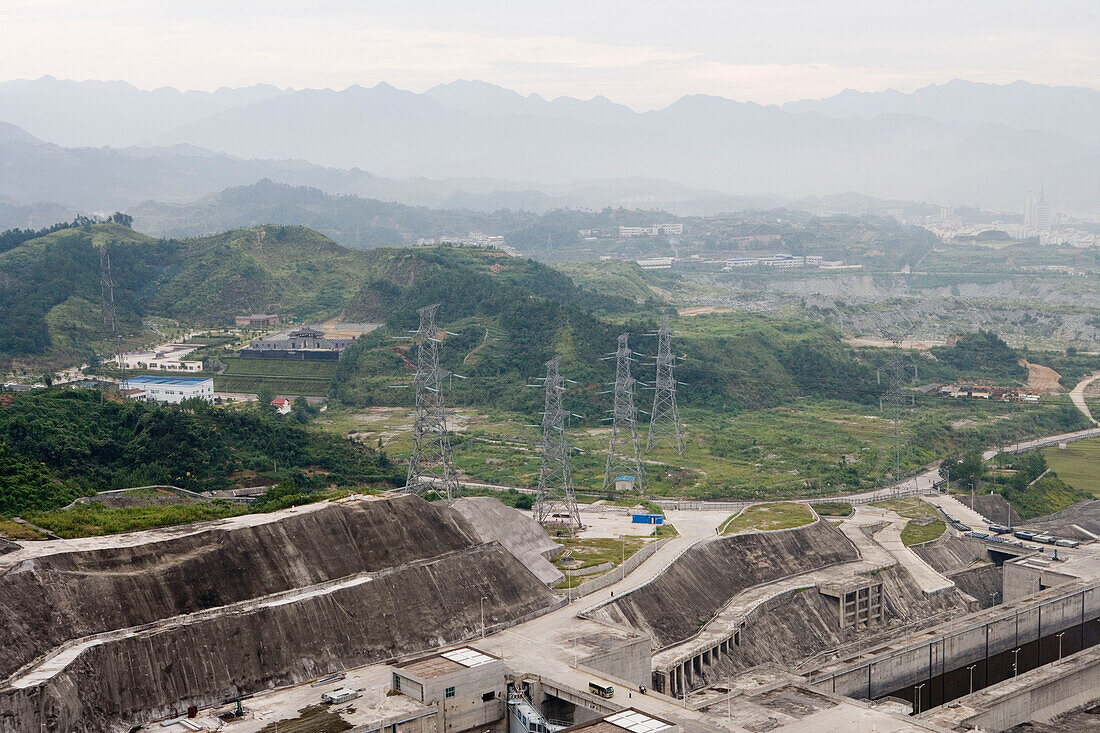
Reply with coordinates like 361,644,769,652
0,543,558,733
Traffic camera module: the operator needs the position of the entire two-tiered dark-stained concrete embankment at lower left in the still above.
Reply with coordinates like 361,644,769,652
0,496,560,733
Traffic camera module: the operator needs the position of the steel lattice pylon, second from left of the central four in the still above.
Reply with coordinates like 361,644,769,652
535,357,582,535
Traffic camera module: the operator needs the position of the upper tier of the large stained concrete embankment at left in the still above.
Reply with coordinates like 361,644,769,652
0,496,480,678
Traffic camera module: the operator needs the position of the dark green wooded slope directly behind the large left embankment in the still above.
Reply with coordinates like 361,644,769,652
0,390,399,515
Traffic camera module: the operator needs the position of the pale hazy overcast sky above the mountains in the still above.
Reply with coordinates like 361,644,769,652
0,0,1100,109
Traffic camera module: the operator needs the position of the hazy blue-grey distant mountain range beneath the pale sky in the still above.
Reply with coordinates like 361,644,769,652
0,77,1100,214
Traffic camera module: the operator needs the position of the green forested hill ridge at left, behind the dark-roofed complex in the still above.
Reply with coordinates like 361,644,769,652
0,216,635,365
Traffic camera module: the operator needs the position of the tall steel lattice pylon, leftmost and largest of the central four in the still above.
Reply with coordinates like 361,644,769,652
405,303,461,499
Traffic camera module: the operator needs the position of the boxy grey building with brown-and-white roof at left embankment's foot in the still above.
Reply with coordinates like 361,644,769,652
392,646,507,733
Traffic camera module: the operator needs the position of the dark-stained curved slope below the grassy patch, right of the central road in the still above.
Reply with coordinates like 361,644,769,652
590,521,859,647
